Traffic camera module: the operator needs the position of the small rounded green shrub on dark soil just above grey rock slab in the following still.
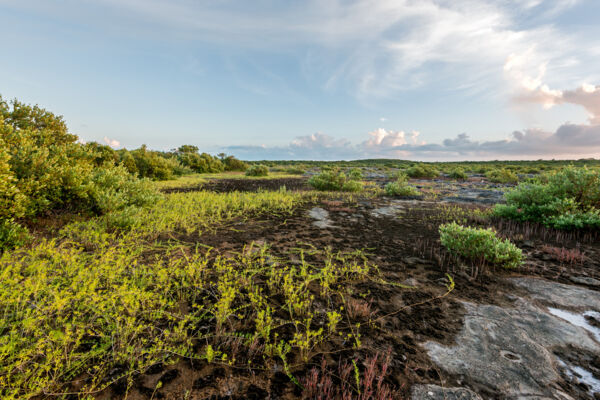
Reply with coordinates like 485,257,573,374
439,222,524,268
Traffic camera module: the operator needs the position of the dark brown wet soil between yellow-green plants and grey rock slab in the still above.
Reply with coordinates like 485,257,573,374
101,179,600,399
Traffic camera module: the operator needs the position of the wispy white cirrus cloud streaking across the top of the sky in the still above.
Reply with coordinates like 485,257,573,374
2,0,600,99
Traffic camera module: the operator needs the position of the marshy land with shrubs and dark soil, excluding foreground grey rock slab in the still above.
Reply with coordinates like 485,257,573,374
0,101,600,399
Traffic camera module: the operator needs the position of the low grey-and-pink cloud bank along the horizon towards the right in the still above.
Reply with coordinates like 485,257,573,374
223,79,600,160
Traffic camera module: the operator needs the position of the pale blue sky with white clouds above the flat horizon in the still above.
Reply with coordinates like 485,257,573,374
0,0,600,161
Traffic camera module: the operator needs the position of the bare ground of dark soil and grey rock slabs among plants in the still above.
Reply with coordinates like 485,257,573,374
134,177,600,400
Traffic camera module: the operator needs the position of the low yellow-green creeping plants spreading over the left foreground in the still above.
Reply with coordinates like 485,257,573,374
0,192,377,399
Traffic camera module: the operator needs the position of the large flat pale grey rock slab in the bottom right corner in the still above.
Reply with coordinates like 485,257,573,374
422,278,600,399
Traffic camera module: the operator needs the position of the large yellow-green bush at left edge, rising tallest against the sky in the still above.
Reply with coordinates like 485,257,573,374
0,97,157,248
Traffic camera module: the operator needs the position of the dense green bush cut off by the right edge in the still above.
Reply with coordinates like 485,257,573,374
494,166,600,229
